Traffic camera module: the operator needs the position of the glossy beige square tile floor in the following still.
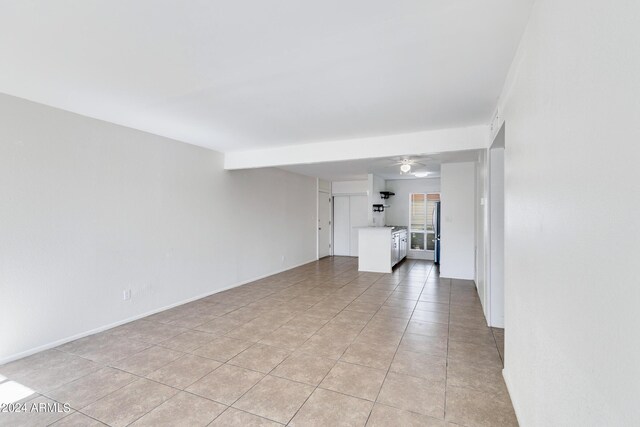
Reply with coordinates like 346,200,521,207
0,257,517,427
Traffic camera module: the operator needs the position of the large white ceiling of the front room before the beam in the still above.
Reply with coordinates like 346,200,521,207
0,0,533,151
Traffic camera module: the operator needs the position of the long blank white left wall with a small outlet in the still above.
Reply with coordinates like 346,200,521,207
0,95,317,362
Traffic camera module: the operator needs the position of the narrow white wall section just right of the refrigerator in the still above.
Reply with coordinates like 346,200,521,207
440,162,476,280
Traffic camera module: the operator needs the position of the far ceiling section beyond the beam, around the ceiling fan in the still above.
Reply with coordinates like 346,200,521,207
280,150,480,181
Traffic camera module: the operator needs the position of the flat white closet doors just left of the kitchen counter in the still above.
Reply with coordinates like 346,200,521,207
333,195,369,256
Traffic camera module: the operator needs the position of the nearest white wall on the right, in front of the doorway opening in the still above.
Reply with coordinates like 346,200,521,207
500,0,640,427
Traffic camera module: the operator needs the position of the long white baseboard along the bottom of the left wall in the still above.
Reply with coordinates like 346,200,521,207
0,259,316,365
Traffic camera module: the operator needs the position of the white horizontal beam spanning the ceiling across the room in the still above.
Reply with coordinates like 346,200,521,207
224,125,490,170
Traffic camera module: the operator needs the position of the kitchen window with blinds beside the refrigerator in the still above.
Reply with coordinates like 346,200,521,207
409,193,440,251
